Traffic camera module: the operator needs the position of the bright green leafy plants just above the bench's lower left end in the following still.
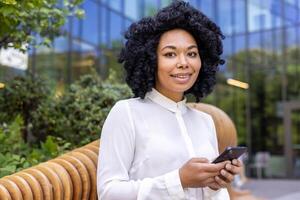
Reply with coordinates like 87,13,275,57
0,115,71,178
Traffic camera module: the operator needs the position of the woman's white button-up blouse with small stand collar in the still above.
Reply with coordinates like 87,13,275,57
97,89,229,200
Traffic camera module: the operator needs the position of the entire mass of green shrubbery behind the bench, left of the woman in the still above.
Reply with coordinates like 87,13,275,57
0,72,132,177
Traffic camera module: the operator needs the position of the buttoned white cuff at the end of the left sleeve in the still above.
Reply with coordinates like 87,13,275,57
164,169,185,199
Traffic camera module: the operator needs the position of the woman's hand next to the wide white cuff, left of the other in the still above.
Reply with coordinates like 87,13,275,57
179,158,230,188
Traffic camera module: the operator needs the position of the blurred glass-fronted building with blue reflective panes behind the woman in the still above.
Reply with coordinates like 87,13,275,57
0,0,300,178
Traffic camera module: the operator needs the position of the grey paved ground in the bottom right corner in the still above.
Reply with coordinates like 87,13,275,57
241,179,300,200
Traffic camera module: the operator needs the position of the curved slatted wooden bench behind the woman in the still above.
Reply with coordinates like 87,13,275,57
0,103,237,200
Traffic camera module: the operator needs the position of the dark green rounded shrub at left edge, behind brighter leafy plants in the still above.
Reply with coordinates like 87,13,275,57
0,75,50,142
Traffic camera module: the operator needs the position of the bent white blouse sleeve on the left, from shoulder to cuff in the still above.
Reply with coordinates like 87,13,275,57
97,101,185,200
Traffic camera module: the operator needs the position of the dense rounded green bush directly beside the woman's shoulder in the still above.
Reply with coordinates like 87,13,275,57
33,75,132,146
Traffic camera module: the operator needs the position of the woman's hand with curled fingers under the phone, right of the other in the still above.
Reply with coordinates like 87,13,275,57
209,159,243,190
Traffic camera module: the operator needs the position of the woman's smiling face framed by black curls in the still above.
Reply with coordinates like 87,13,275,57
155,29,201,102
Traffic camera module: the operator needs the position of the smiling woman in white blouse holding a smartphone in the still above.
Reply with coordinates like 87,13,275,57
97,1,241,200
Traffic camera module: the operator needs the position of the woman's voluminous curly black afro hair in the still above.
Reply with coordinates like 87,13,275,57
119,0,224,102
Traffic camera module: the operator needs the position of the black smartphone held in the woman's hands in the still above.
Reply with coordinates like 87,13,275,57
212,147,247,163
